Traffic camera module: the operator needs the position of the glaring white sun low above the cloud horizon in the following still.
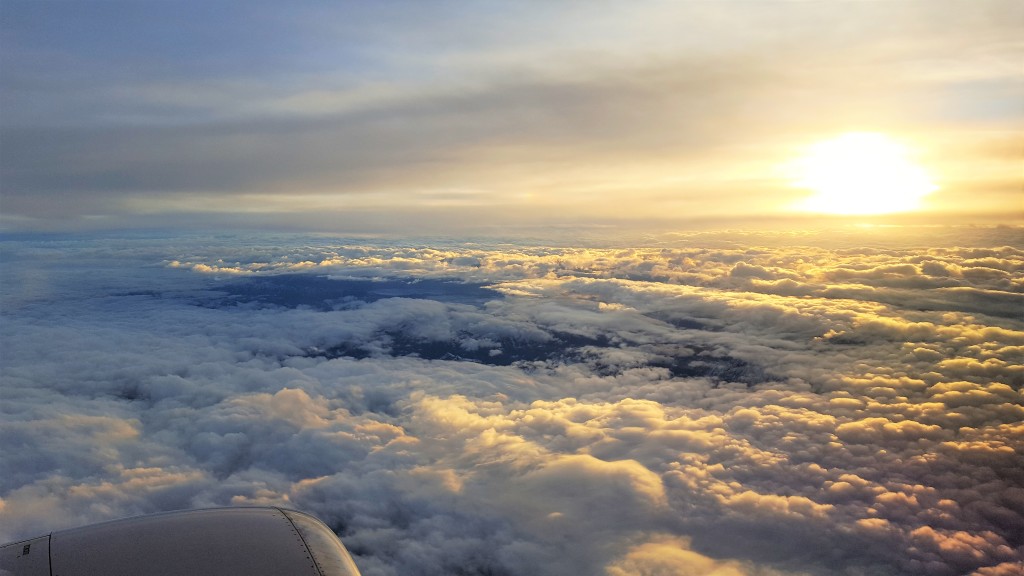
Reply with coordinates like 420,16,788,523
793,132,938,215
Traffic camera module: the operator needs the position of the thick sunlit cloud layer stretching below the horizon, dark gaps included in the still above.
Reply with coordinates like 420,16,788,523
0,229,1024,576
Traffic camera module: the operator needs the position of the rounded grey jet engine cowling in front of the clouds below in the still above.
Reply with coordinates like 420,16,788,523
0,507,359,576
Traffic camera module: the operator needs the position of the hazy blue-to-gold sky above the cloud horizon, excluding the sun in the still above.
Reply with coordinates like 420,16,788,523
0,0,1024,232
